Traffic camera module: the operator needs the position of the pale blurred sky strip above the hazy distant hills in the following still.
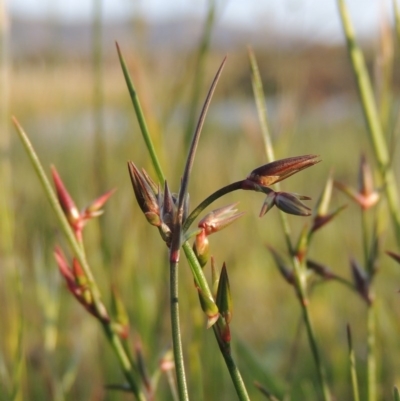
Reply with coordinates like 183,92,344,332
5,0,400,42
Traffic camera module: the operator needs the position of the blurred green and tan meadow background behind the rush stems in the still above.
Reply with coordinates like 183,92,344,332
0,2,400,400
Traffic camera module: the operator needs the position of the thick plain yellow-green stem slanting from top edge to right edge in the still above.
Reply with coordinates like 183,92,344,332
338,0,400,246
